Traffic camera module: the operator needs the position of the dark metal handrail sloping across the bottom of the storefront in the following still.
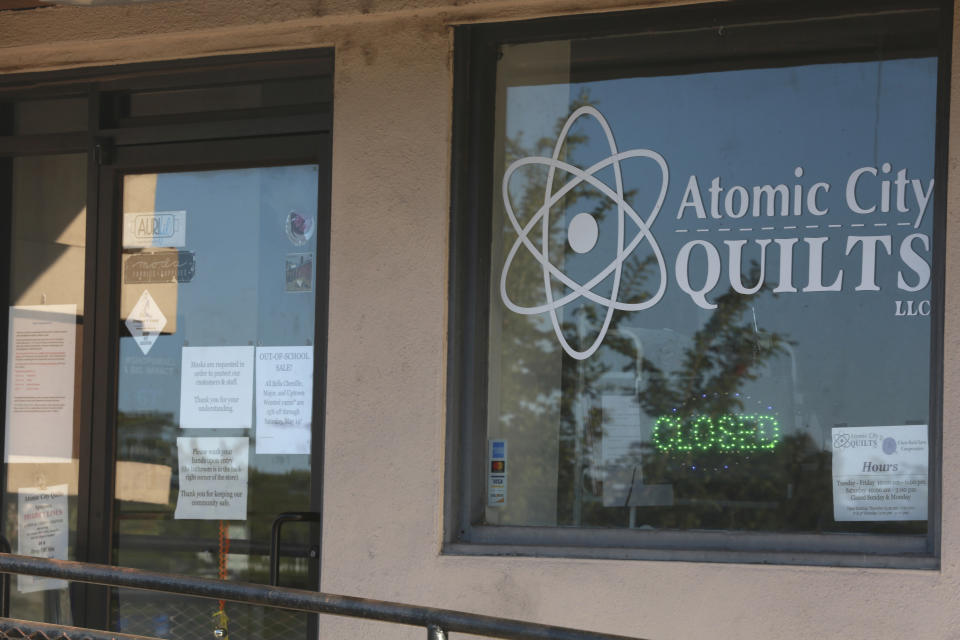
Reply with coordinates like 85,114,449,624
0,553,652,640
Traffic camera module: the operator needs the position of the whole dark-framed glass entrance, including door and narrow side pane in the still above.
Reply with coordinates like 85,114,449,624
0,49,333,640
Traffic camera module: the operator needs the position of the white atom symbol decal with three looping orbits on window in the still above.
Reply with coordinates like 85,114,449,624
500,106,669,360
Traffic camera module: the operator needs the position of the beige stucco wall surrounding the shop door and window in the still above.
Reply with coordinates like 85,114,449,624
0,0,960,639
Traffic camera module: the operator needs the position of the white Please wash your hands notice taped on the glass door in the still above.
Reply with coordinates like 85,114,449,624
173,438,250,520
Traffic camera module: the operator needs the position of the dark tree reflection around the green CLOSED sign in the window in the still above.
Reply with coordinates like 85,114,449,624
560,264,832,531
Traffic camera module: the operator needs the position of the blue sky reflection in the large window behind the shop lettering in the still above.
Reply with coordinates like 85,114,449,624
496,58,936,437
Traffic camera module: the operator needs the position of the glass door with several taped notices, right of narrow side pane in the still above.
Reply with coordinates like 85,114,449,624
91,135,326,640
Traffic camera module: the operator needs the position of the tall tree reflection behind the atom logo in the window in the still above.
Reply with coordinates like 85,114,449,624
493,95,632,524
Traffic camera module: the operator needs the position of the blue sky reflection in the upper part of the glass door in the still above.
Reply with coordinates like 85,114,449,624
118,165,318,466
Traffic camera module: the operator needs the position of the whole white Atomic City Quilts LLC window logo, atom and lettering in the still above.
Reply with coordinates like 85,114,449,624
500,106,934,360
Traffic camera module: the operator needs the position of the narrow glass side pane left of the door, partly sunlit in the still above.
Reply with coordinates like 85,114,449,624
0,153,91,624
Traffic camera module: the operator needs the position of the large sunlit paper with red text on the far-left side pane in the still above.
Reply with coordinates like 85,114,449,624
4,304,77,462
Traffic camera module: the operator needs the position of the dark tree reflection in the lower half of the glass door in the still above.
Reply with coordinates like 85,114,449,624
111,412,311,640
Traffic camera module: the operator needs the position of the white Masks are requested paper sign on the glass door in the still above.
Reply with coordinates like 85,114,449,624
180,347,254,429
